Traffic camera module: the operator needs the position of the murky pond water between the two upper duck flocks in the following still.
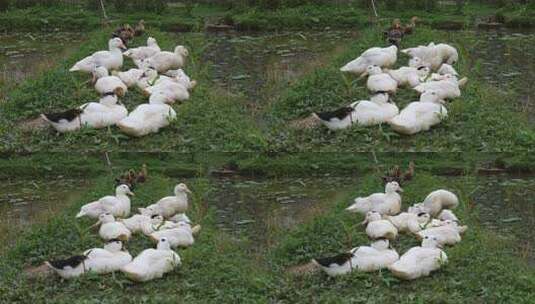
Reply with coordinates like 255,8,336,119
203,31,356,108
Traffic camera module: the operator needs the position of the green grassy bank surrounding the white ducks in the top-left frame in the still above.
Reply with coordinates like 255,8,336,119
0,30,265,152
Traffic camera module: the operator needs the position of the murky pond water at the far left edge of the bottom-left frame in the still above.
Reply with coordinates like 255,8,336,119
0,177,88,247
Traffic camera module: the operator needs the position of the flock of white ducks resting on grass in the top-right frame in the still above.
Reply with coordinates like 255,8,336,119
312,42,467,135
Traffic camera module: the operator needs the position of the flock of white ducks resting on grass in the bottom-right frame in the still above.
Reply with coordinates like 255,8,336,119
312,181,467,280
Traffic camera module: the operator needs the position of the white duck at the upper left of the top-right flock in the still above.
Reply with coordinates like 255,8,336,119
340,45,398,75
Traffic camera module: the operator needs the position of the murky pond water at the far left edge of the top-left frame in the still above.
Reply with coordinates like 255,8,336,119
0,32,81,97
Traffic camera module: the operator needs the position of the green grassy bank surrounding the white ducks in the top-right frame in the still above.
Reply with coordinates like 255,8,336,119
266,27,535,152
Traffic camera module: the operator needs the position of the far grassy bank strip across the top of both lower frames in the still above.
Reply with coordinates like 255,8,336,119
0,152,535,179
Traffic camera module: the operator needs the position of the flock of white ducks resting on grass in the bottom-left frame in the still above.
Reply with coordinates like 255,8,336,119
45,183,200,282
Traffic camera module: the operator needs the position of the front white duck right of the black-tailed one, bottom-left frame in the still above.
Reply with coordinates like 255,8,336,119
121,238,181,282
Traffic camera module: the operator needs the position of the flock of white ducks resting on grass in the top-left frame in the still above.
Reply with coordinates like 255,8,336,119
41,37,196,137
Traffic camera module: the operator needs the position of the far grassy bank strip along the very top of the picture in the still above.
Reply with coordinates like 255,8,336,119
0,3,535,31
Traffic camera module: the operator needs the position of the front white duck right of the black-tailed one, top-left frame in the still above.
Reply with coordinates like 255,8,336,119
117,94,176,137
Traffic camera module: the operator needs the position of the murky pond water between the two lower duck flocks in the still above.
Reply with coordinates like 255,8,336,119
208,177,357,245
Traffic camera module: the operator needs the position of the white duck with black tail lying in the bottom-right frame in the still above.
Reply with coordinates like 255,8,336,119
312,239,399,276
